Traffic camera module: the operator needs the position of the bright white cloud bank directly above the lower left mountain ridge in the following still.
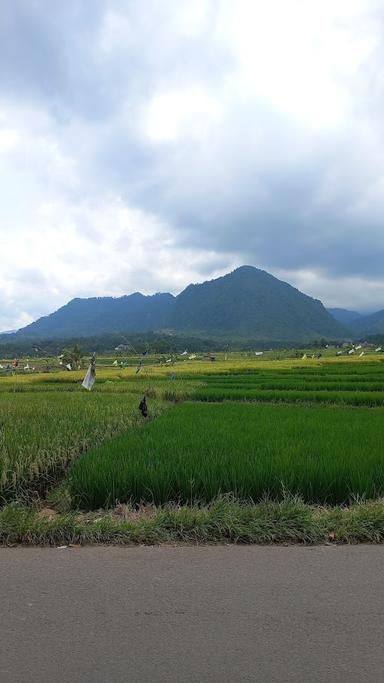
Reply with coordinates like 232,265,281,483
0,190,237,329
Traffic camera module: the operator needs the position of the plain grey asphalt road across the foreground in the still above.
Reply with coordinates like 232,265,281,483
0,546,384,683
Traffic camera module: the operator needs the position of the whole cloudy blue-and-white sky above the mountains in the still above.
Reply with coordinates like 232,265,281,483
0,0,384,330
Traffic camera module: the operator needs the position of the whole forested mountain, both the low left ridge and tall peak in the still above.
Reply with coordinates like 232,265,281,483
2,266,349,343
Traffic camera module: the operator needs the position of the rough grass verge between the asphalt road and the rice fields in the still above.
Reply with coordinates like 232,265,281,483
0,497,384,546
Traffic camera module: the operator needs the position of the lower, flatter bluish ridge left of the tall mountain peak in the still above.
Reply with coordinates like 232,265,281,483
14,292,174,341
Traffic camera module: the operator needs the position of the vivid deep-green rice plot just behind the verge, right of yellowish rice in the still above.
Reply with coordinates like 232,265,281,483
68,402,384,508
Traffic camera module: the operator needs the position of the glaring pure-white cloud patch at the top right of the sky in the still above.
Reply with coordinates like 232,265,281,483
221,0,380,128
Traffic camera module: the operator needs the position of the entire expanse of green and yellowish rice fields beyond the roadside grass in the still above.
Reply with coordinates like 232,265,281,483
0,353,384,508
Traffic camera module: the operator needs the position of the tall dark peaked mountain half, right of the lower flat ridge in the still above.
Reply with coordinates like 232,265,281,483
172,266,346,341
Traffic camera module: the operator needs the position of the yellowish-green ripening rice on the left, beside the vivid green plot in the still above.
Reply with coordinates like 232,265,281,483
0,369,204,501
